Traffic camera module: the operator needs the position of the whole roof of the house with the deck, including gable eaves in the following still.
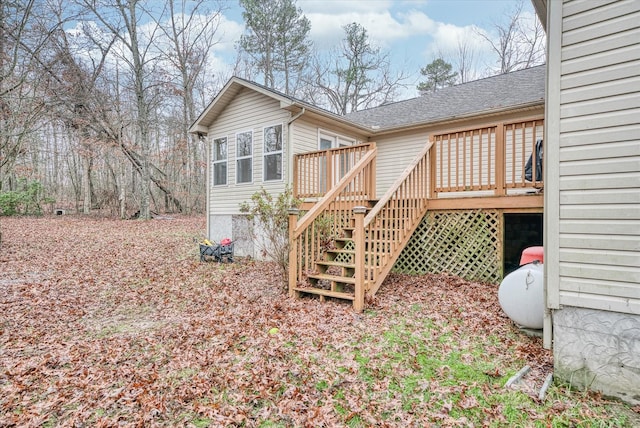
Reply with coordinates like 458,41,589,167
189,65,546,135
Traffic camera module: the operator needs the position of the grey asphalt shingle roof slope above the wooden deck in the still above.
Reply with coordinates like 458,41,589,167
345,65,546,130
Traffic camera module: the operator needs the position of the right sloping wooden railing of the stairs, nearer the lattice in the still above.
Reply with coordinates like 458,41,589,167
354,141,433,300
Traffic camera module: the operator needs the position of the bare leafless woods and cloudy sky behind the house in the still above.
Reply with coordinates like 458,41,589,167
0,0,544,227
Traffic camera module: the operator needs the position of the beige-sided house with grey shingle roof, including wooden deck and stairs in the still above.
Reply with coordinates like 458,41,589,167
190,66,545,309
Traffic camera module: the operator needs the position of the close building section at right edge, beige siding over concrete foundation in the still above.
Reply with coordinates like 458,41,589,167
532,0,640,404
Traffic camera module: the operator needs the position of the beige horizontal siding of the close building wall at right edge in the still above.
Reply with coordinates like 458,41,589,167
548,0,640,314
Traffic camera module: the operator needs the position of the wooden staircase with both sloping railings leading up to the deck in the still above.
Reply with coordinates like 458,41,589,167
289,143,431,311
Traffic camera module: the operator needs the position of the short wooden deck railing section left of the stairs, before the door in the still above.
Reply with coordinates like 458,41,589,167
293,143,375,199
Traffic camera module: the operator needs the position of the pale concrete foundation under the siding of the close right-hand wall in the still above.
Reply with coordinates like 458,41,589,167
553,307,640,405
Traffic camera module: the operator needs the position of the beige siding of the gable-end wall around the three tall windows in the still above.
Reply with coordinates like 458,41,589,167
209,89,290,216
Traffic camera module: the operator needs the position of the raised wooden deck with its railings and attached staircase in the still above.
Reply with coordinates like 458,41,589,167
289,118,543,311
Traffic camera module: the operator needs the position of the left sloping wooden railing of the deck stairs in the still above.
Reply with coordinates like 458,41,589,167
289,143,377,297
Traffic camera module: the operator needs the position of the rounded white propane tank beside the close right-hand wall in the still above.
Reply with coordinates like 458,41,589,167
498,263,544,329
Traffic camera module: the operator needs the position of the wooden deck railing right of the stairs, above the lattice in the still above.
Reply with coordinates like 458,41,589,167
431,119,543,196
